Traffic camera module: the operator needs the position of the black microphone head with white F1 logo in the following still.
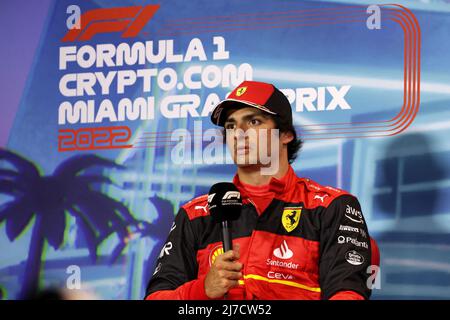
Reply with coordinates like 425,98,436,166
208,182,242,223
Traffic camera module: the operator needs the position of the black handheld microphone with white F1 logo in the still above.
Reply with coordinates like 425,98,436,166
208,182,242,252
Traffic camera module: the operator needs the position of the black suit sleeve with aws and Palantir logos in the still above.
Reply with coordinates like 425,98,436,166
319,195,371,299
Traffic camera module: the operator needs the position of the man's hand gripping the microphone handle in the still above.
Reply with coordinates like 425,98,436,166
205,244,242,299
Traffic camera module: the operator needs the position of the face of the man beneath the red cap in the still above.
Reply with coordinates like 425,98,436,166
224,107,281,167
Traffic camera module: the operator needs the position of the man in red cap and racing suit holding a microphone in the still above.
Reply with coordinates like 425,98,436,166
146,81,372,299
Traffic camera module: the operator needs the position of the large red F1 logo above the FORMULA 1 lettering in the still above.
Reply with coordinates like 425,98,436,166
61,4,159,42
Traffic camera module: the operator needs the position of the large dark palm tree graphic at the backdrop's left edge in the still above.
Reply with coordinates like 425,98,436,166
0,148,136,298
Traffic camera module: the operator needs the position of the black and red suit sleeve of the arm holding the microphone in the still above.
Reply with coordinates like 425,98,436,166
145,208,208,300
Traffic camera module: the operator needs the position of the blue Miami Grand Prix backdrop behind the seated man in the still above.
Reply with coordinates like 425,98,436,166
0,0,450,299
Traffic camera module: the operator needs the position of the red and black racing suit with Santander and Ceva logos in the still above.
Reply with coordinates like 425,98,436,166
146,167,371,300
